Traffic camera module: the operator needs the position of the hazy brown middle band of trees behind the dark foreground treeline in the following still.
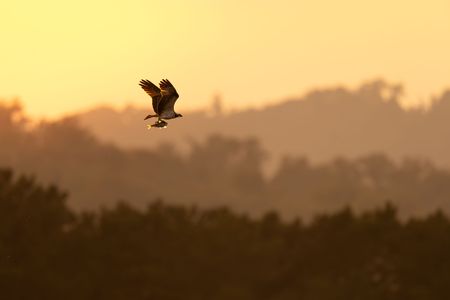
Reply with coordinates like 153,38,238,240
0,100,450,218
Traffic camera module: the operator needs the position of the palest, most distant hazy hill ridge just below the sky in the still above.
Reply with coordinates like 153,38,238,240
77,80,450,167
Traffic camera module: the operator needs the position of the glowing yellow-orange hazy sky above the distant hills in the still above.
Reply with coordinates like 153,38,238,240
0,0,450,117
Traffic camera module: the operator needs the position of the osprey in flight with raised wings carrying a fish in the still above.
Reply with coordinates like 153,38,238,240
139,79,182,129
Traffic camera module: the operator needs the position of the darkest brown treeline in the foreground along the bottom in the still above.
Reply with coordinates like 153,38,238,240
0,170,450,300
